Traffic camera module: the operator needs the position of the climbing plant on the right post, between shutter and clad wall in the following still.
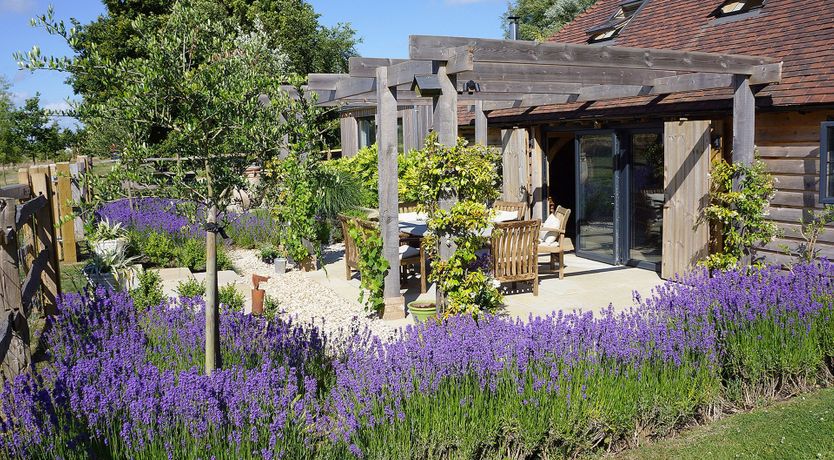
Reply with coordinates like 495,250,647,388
701,160,778,270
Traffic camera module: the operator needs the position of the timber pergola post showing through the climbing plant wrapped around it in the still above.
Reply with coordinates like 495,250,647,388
432,61,458,311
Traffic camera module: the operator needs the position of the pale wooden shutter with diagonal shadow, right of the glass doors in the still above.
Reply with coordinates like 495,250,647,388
661,121,711,279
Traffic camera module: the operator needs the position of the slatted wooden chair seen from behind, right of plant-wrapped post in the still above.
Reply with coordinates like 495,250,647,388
492,219,541,296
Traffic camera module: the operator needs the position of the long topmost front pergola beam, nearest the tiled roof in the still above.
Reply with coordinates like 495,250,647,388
409,35,778,76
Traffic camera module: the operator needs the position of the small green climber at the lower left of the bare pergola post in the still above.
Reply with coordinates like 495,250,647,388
348,219,390,314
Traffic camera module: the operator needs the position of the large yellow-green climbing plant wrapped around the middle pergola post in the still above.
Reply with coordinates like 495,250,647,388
414,133,503,316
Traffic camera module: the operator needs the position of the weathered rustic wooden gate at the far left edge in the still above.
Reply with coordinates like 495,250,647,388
0,175,60,384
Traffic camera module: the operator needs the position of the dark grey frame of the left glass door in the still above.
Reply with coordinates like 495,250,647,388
574,129,628,266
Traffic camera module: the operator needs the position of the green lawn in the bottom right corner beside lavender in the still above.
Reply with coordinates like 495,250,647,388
617,389,834,460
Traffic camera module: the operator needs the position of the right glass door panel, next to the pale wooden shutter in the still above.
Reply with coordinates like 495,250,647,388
628,132,665,270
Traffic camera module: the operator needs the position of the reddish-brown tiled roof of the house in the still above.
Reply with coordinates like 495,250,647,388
462,0,834,121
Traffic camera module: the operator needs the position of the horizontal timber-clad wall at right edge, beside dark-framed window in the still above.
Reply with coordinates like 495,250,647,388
756,110,834,263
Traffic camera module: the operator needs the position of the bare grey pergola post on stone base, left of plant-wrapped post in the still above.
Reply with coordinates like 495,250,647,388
376,67,405,319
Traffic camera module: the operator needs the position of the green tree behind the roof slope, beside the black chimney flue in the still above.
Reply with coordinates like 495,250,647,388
503,0,596,41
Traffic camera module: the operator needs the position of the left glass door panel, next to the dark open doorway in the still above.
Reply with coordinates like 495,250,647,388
576,131,620,265
